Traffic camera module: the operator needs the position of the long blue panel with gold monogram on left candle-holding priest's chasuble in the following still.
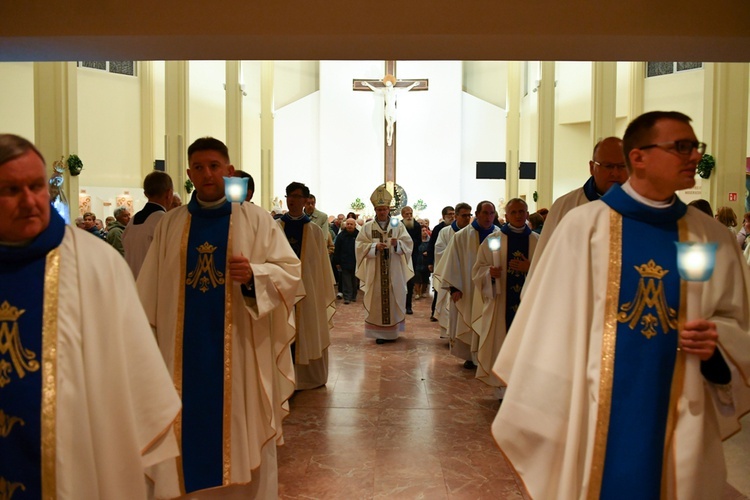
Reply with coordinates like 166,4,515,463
182,203,231,493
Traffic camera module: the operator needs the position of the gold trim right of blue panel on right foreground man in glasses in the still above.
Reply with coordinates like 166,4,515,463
661,217,688,498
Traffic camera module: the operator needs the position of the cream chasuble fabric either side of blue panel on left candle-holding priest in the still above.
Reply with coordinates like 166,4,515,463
137,203,300,498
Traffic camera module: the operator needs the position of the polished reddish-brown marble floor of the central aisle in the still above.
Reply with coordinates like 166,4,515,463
278,294,750,500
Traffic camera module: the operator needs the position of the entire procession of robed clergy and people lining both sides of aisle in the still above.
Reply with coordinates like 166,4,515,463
0,111,750,499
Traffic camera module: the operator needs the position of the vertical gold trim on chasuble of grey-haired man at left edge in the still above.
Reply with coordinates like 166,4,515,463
41,248,60,499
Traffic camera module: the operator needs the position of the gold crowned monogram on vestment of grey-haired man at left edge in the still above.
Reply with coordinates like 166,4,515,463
0,300,40,387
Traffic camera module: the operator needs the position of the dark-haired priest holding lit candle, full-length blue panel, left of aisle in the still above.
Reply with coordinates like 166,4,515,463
137,137,300,499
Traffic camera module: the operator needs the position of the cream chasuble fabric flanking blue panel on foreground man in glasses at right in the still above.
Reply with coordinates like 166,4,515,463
492,201,750,499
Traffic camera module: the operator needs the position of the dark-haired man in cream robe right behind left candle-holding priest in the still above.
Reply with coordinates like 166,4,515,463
277,182,336,390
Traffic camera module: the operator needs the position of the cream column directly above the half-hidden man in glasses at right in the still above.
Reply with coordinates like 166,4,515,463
591,62,617,147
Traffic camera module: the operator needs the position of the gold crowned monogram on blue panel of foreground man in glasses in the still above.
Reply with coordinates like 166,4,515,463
617,259,677,339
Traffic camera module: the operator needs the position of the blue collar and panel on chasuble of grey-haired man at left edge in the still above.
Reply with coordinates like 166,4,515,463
0,210,65,498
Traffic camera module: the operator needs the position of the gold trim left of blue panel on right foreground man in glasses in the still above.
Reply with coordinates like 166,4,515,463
587,209,622,500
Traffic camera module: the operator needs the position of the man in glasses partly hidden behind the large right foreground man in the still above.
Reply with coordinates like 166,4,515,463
528,137,628,278
